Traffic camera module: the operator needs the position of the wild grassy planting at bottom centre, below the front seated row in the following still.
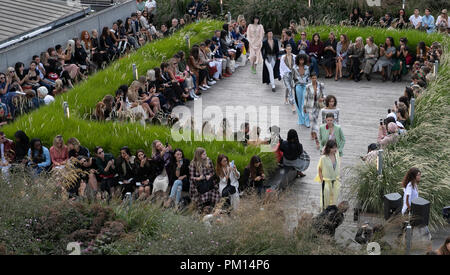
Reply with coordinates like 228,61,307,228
102,194,357,255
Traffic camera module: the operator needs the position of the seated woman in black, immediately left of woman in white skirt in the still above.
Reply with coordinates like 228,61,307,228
136,149,157,198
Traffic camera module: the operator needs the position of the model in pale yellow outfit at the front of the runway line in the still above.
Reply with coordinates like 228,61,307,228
314,141,341,211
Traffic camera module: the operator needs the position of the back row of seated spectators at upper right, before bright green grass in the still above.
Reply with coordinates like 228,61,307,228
280,29,442,82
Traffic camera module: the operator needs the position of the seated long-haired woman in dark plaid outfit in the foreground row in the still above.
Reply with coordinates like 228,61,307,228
189,147,220,212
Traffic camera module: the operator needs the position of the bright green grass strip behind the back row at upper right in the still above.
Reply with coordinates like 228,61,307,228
295,26,444,54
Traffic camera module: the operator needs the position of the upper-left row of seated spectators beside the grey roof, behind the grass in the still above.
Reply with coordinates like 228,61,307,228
0,8,192,126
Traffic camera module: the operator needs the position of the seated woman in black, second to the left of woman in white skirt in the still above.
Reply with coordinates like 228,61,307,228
115,146,137,198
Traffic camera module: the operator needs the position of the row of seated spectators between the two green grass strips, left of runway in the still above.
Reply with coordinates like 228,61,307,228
94,20,255,123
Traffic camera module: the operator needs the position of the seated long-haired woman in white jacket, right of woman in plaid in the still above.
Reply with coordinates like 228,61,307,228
216,154,240,209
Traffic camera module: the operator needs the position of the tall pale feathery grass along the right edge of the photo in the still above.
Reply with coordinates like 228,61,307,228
352,39,450,228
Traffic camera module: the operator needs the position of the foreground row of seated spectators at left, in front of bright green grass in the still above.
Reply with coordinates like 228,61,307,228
0,131,265,213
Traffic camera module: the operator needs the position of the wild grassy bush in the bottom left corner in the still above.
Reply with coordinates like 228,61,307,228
0,172,123,255
